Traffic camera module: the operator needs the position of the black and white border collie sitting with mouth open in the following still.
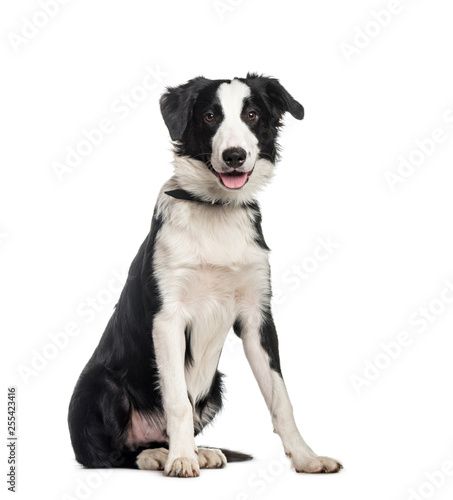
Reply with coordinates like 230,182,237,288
69,74,342,477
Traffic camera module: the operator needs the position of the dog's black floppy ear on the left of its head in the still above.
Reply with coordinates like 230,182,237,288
160,76,210,141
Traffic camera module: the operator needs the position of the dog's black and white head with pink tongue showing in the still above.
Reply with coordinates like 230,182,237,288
160,74,304,203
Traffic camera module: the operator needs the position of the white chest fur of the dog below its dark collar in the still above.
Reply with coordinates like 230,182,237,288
154,195,269,402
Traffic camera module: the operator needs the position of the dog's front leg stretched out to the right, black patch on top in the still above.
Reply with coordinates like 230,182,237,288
235,308,342,473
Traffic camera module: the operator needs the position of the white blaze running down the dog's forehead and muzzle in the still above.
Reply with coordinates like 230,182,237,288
212,80,258,171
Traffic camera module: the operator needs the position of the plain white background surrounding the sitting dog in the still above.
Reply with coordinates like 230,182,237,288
0,0,453,500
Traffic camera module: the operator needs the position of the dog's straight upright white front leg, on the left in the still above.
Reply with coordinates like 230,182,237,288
153,311,200,477
